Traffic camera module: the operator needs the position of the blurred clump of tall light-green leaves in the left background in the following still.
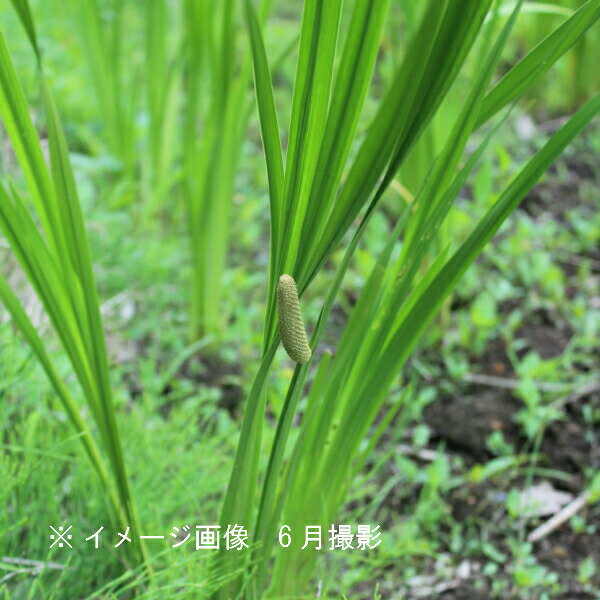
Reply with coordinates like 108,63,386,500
65,0,251,341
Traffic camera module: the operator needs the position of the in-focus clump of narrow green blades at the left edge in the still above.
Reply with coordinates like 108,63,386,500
0,0,145,559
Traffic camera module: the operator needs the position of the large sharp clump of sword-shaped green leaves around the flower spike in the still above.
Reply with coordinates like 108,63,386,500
213,1,600,597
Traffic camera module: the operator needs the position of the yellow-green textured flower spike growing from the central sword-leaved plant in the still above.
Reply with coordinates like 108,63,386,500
277,275,311,365
